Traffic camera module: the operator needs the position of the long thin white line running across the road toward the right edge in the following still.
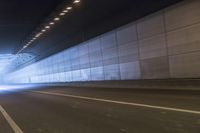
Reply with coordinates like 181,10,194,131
31,91,200,115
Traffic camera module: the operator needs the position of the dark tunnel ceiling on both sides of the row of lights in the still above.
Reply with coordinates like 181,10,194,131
0,0,181,65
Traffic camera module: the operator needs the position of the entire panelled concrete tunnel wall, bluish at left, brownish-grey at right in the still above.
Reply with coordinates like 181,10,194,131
5,0,200,83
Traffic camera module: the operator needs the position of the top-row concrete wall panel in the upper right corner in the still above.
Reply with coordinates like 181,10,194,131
165,0,200,31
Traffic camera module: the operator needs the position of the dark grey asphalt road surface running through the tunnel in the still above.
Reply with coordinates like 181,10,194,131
0,87,200,133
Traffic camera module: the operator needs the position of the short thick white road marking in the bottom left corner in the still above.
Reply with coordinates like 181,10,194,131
0,105,23,133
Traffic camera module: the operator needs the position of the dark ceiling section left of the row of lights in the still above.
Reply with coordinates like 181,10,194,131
0,0,66,54
